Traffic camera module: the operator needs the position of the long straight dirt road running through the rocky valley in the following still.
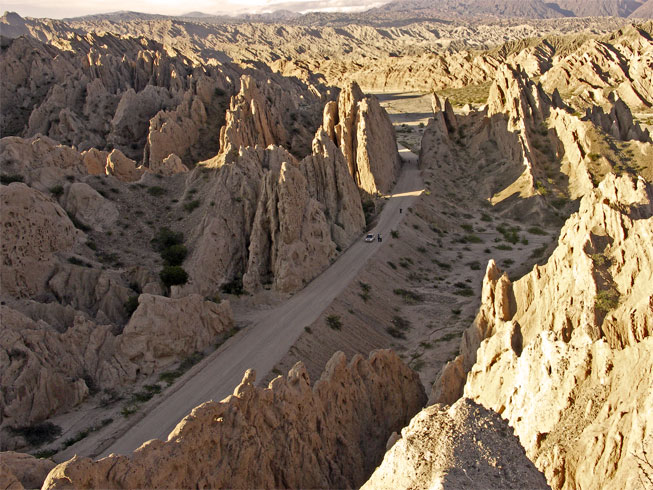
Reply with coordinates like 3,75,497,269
90,147,423,457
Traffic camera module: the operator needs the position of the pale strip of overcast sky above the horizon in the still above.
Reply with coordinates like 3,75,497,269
0,0,388,19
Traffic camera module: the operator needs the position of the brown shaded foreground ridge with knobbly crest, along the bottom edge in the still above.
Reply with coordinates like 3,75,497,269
44,351,425,488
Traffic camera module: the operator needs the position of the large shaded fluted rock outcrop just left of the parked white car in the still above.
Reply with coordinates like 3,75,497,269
185,133,365,294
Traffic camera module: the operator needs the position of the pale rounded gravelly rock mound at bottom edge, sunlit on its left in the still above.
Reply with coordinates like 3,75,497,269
362,398,549,490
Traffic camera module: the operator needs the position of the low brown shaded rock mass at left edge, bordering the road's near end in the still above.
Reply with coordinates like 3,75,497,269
0,294,232,438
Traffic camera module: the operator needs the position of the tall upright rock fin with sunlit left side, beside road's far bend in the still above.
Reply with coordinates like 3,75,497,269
322,83,401,194
